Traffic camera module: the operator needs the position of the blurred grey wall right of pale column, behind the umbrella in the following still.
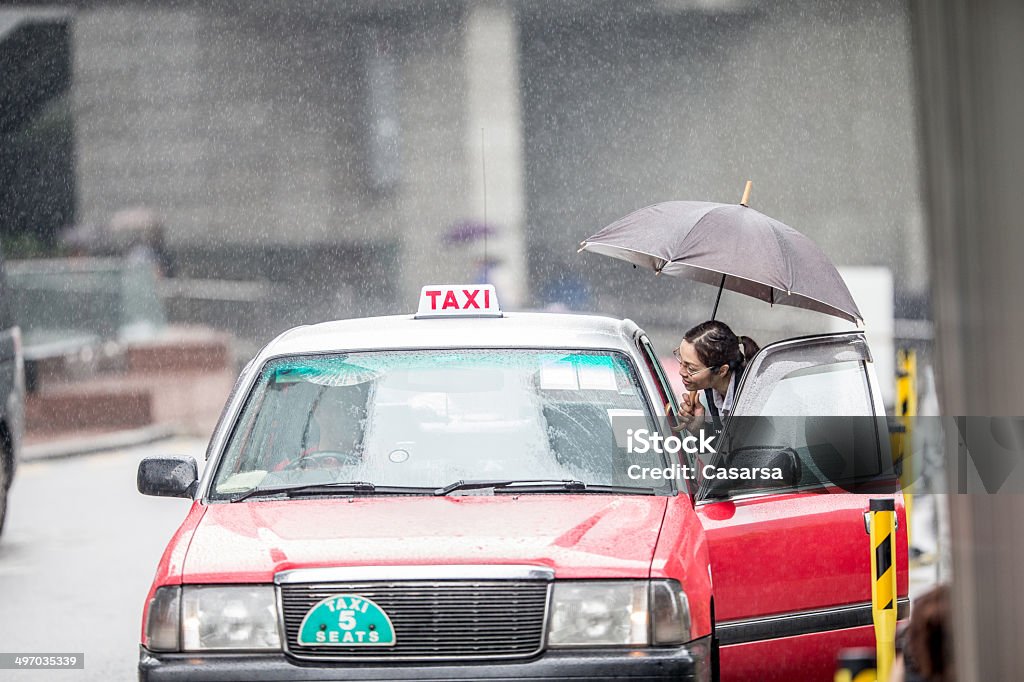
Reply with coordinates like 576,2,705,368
521,0,928,340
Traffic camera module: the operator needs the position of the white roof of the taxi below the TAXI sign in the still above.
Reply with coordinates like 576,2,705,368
260,312,639,359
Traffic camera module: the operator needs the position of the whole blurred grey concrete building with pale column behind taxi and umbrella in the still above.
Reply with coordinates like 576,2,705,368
4,0,928,341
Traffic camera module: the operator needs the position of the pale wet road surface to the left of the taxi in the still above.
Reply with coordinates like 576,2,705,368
0,439,206,682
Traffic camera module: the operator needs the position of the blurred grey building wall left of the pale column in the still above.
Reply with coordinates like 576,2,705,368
74,2,479,318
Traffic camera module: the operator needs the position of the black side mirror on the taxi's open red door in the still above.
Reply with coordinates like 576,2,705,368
706,445,801,498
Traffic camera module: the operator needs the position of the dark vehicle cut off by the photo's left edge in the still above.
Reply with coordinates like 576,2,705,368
0,242,25,531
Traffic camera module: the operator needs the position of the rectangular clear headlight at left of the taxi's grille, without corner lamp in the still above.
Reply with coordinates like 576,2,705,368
181,585,281,651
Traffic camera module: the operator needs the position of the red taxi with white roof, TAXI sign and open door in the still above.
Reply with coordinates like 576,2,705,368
138,286,907,680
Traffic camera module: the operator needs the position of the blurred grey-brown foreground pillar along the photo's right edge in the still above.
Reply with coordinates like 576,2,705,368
912,0,1024,680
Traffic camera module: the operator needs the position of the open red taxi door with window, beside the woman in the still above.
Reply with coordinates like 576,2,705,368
695,333,909,682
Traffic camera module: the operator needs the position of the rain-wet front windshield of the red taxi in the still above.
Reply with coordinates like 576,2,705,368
210,349,669,499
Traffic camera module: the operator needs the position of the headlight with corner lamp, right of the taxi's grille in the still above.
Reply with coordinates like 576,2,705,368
548,581,690,648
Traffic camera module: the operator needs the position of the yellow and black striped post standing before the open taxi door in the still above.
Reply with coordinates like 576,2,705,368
868,498,896,682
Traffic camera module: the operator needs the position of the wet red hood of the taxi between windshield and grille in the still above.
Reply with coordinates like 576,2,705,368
182,494,668,583
